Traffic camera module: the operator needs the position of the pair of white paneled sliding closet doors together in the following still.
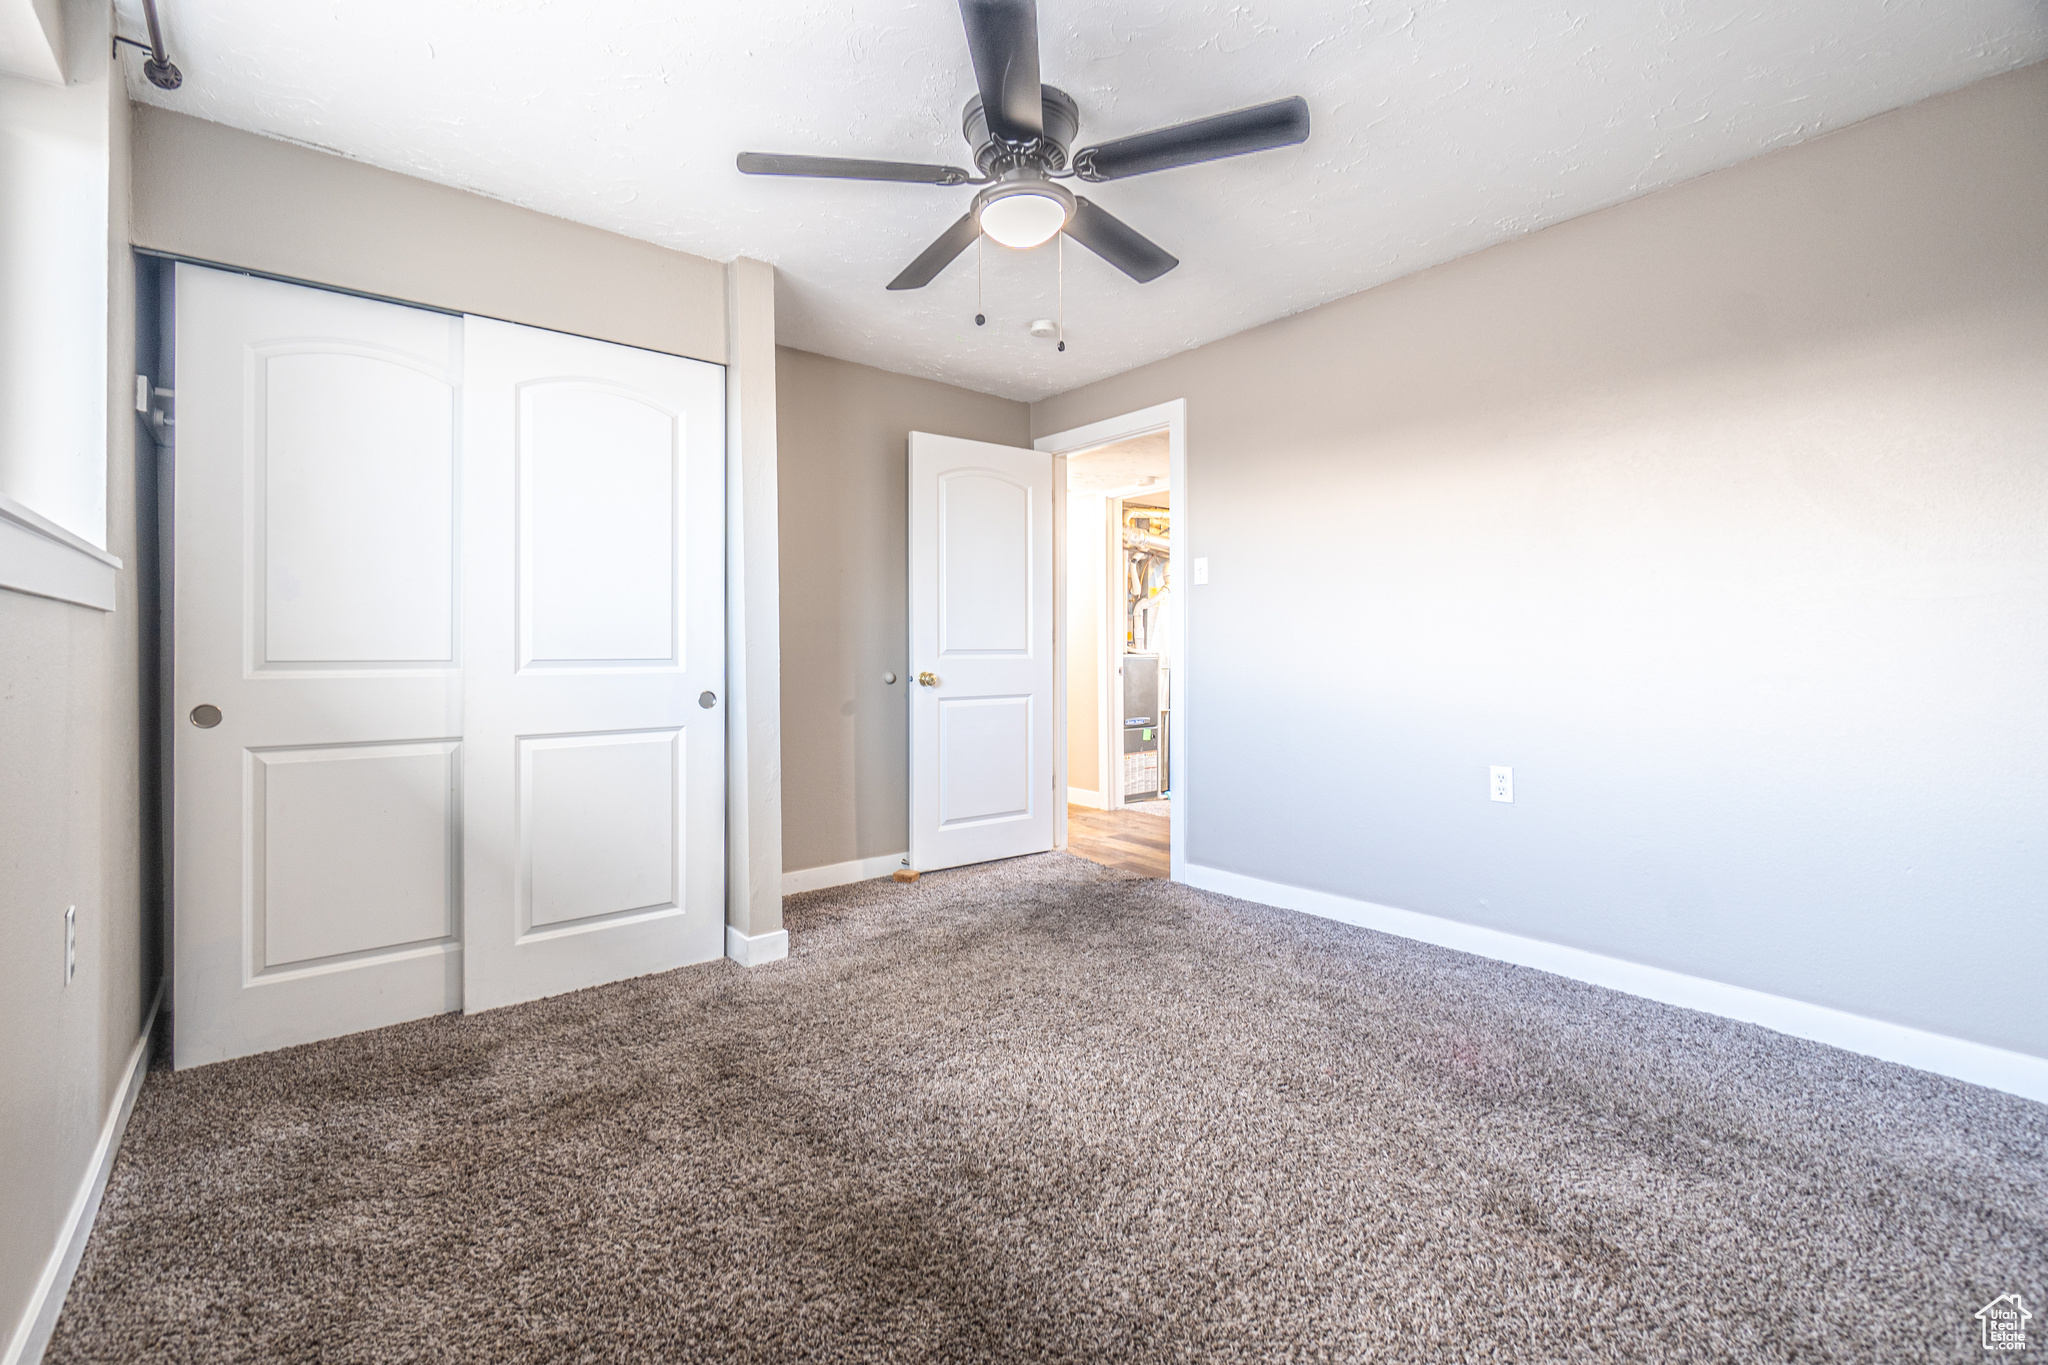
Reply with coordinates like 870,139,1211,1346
172,264,725,1066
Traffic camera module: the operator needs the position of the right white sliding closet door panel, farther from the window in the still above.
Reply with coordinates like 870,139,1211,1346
463,317,725,1011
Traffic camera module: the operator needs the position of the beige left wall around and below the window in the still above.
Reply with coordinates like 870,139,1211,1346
0,18,156,1349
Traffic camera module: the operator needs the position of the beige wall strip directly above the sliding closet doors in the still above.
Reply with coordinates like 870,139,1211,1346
135,106,725,364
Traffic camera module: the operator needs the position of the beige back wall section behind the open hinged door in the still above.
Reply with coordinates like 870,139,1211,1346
776,348,1030,870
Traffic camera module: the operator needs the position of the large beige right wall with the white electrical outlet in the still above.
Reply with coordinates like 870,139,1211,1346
1032,65,2048,1056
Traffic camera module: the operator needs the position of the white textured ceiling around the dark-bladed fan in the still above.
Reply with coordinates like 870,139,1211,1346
119,0,2048,399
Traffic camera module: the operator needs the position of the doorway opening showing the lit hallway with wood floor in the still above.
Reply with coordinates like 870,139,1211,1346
1065,428,1180,878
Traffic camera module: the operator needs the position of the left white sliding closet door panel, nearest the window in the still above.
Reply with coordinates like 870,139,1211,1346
172,264,463,1066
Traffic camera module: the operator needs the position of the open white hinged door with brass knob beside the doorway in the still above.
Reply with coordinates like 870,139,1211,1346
909,432,1059,872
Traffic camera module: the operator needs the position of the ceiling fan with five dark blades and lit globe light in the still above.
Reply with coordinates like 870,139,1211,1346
739,0,1309,289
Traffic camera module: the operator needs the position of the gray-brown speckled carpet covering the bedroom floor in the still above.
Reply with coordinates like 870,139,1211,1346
47,853,2048,1365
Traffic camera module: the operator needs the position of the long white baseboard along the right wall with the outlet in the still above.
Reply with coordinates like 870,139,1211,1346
1182,864,2048,1103
